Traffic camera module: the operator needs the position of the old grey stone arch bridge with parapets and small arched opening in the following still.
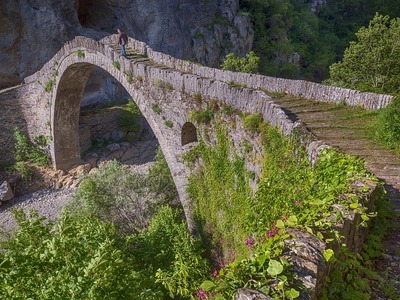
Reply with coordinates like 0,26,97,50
0,35,391,229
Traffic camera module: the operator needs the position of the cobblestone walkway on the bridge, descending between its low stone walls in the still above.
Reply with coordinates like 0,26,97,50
273,97,400,299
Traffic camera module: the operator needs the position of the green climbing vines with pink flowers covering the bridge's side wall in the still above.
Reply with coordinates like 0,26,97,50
185,117,375,299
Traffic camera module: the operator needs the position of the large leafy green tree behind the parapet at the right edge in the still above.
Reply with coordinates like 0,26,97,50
328,14,400,94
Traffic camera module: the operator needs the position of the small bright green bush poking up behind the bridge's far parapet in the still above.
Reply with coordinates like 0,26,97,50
221,51,260,73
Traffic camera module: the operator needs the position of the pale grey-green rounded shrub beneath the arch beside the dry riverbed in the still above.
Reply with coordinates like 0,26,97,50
73,160,157,232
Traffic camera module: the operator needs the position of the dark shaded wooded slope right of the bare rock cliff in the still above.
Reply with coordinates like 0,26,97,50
239,0,400,81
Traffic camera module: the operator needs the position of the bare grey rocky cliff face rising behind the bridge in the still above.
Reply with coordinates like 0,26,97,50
0,0,253,87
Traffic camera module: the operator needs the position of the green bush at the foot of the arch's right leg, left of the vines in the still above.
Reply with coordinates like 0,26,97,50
133,207,209,299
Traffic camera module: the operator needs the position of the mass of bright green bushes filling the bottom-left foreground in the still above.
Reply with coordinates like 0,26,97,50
0,206,209,300
